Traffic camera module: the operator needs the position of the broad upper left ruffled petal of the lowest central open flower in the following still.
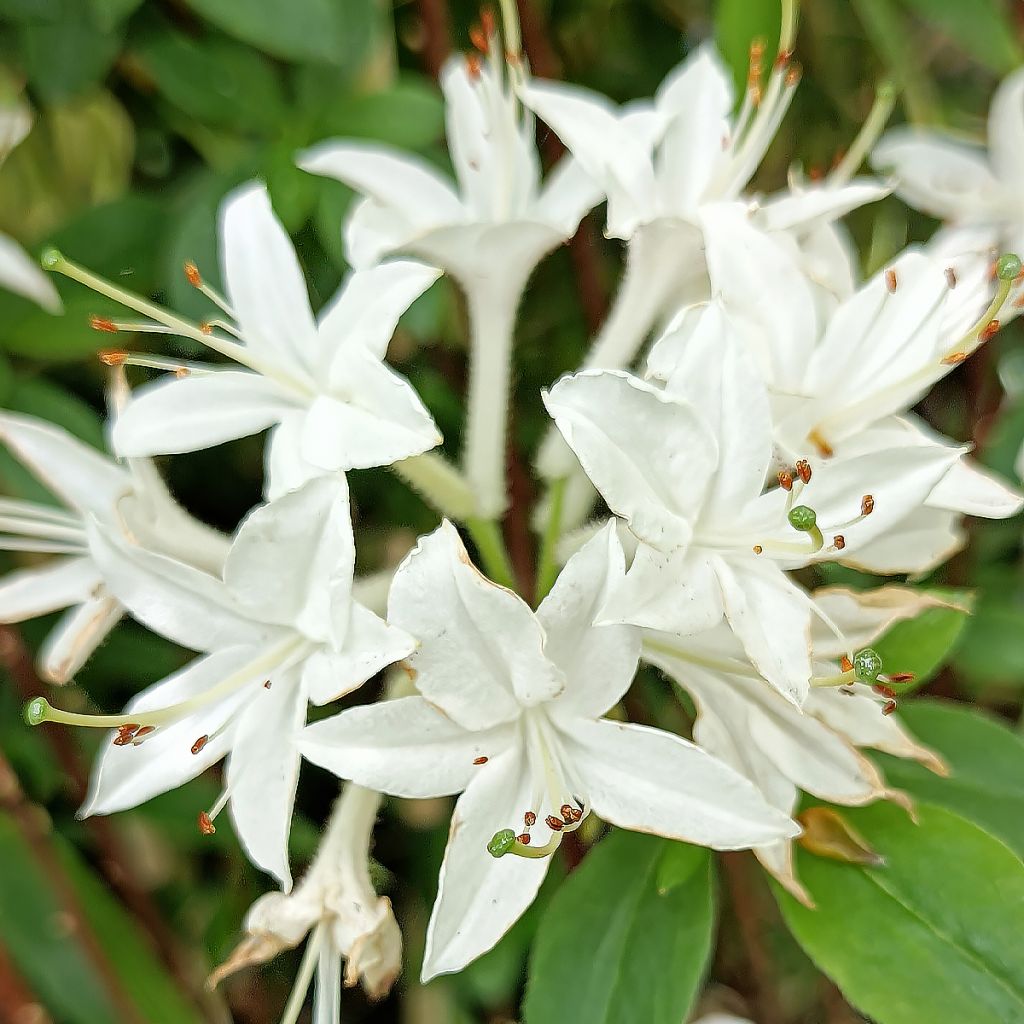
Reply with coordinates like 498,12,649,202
388,520,565,729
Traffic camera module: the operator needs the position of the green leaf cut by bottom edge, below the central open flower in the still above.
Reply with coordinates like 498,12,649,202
523,831,714,1024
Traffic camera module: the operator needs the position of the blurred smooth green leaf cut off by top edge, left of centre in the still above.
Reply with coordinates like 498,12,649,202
188,0,374,65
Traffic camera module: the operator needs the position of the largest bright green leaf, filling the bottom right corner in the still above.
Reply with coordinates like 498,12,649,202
775,804,1024,1024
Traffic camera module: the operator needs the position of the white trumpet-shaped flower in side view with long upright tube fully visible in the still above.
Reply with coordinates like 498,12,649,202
299,32,599,516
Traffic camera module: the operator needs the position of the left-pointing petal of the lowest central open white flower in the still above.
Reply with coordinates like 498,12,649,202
301,697,514,798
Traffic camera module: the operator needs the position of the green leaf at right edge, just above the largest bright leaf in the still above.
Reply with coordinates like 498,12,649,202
874,700,1024,857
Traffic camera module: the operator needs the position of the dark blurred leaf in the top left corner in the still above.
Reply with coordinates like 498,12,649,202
18,0,121,102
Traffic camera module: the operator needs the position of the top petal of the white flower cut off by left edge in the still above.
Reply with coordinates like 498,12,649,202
0,413,130,514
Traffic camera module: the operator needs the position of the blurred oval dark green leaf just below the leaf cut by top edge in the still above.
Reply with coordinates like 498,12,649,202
128,22,286,134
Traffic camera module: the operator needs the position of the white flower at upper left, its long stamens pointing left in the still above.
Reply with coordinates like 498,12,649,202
46,184,441,498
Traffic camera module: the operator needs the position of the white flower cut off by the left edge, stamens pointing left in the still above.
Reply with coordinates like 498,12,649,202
0,385,227,683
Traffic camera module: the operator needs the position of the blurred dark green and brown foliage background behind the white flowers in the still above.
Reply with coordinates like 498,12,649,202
0,0,1024,1024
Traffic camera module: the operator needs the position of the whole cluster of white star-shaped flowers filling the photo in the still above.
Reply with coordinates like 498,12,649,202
0,2,1024,1022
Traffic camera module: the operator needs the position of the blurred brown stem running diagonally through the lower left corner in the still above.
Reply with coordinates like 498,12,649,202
0,626,227,1024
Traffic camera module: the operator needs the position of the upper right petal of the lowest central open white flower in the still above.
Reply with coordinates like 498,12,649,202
537,522,640,718
